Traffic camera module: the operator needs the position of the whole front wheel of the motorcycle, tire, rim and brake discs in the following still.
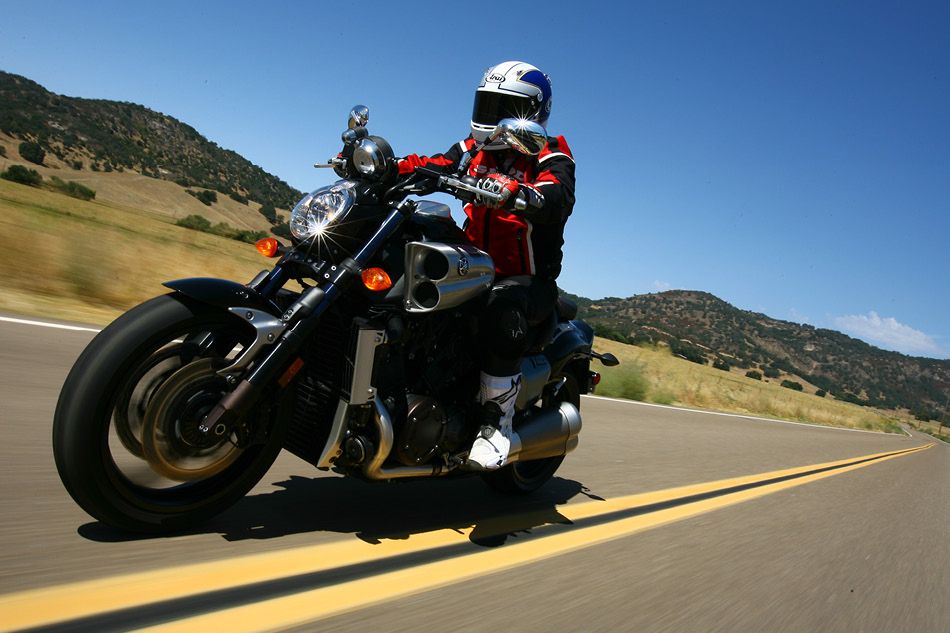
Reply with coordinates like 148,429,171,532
53,294,292,532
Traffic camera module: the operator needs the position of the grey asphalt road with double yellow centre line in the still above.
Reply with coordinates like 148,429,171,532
0,321,950,633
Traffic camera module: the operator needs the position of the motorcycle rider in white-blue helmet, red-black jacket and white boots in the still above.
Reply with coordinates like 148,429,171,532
399,61,574,470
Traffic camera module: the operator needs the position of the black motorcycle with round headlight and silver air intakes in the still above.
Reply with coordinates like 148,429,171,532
53,106,617,532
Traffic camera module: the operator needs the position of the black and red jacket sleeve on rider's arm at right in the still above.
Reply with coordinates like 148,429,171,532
517,136,574,224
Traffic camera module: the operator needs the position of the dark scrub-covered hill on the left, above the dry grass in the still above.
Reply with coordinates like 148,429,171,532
0,71,303,209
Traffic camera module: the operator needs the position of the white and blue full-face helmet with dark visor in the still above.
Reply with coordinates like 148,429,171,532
472,62,551,149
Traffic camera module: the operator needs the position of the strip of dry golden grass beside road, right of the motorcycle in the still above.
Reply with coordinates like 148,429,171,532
596,339,900,433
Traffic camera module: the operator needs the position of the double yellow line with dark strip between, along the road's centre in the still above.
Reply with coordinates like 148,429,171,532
0,444,933,633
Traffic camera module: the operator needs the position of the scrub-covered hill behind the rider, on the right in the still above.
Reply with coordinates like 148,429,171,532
575,290,950,419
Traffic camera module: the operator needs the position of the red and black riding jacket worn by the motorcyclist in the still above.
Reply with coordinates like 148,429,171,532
399,136,574,279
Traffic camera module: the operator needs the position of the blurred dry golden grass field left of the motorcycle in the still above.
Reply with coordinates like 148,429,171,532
0,180,276,323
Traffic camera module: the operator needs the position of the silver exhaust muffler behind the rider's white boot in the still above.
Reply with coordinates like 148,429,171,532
508,402,581,463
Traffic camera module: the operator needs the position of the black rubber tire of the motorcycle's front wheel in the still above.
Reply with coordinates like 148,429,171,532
53,294,293,532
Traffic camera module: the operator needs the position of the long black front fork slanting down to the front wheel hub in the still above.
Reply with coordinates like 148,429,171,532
198,200,416,436
